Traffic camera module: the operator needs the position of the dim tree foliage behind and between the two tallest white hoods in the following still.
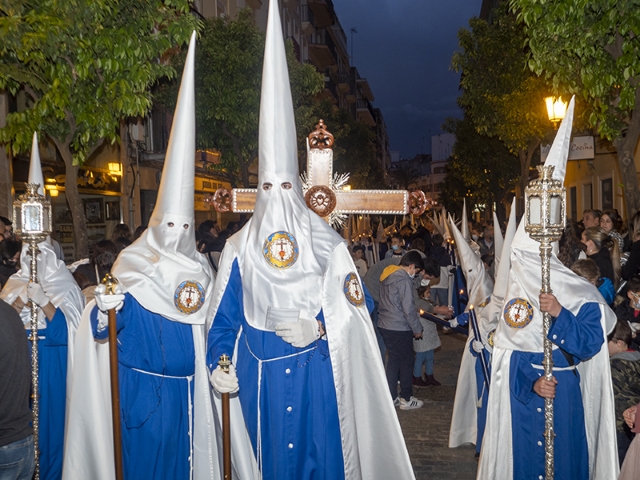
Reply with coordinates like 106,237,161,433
158,9,324,187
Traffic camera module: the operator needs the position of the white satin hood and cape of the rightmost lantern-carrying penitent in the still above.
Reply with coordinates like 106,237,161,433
478,95,618,480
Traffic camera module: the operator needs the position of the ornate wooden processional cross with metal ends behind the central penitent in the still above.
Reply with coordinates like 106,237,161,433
211,120,430,225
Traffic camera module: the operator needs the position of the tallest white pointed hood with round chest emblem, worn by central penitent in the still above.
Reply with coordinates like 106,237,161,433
229,1,343,330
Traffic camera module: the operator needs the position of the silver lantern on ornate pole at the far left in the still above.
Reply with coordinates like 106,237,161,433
13,183,52,480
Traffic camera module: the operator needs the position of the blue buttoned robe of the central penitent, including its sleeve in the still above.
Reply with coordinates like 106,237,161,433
207,260,344,480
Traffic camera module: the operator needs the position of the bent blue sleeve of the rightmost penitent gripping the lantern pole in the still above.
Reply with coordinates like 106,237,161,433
547,302,604,361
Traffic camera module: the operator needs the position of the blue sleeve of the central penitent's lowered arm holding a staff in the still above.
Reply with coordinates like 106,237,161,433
207,259,244,371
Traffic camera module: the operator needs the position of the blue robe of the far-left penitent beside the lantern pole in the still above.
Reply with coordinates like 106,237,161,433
27,309,69,480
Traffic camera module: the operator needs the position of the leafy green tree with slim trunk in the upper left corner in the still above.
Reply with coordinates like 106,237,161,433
0,0,197,257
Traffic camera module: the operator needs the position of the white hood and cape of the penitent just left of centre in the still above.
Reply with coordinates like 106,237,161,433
63,32,222,480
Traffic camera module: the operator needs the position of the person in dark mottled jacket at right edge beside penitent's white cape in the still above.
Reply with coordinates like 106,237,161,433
607,320,640,465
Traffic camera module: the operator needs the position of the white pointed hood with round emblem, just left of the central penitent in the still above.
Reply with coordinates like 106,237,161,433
112,32,214,325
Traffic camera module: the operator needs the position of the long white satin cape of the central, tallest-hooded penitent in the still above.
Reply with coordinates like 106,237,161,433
207,242,415,480
